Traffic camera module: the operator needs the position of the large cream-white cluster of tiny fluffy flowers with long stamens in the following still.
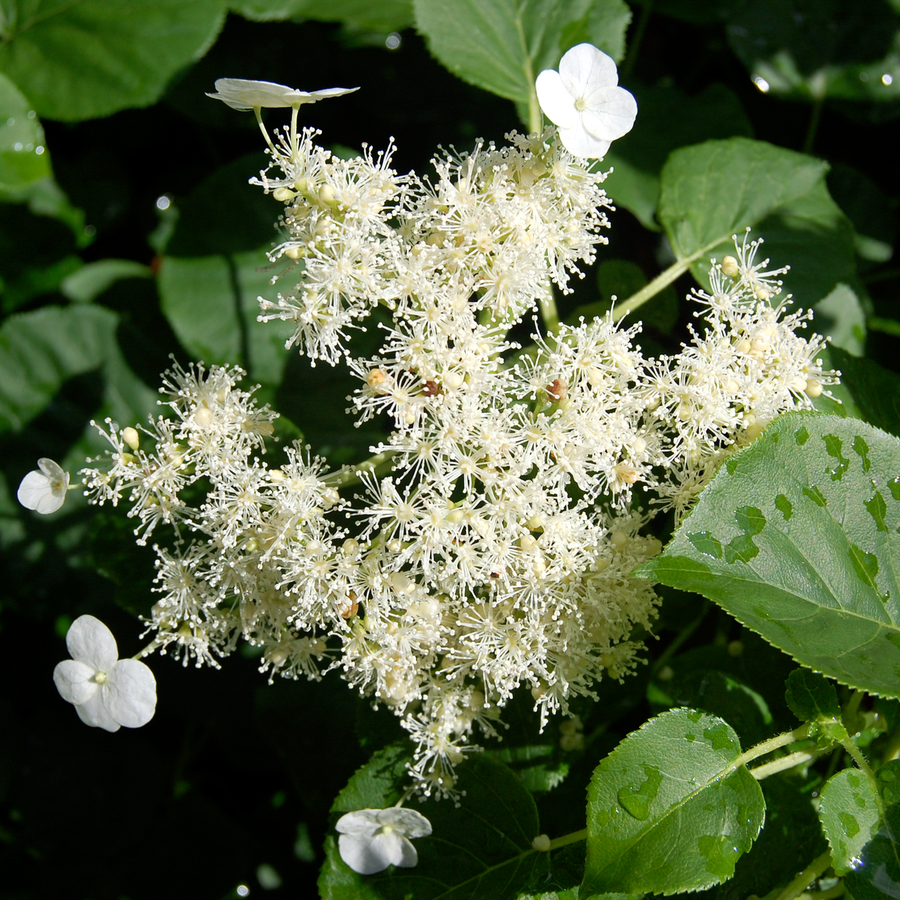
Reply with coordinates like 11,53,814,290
65,72,834,800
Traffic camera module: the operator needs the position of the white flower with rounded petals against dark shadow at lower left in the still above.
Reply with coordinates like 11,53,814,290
53,616,156,731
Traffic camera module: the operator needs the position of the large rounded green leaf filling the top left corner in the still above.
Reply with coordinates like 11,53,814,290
0,0,225,122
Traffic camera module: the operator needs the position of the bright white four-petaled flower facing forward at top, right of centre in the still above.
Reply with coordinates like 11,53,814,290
535,44,637,159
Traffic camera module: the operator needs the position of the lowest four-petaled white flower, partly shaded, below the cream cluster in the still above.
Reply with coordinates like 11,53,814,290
335,807,431,875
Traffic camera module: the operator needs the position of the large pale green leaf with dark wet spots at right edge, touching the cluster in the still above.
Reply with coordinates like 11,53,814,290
638,413,900,697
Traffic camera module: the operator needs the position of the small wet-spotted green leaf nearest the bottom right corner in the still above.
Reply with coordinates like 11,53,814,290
819,769,881,875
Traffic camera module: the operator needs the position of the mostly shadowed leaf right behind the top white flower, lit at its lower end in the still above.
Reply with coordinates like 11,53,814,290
603,84,753,231
